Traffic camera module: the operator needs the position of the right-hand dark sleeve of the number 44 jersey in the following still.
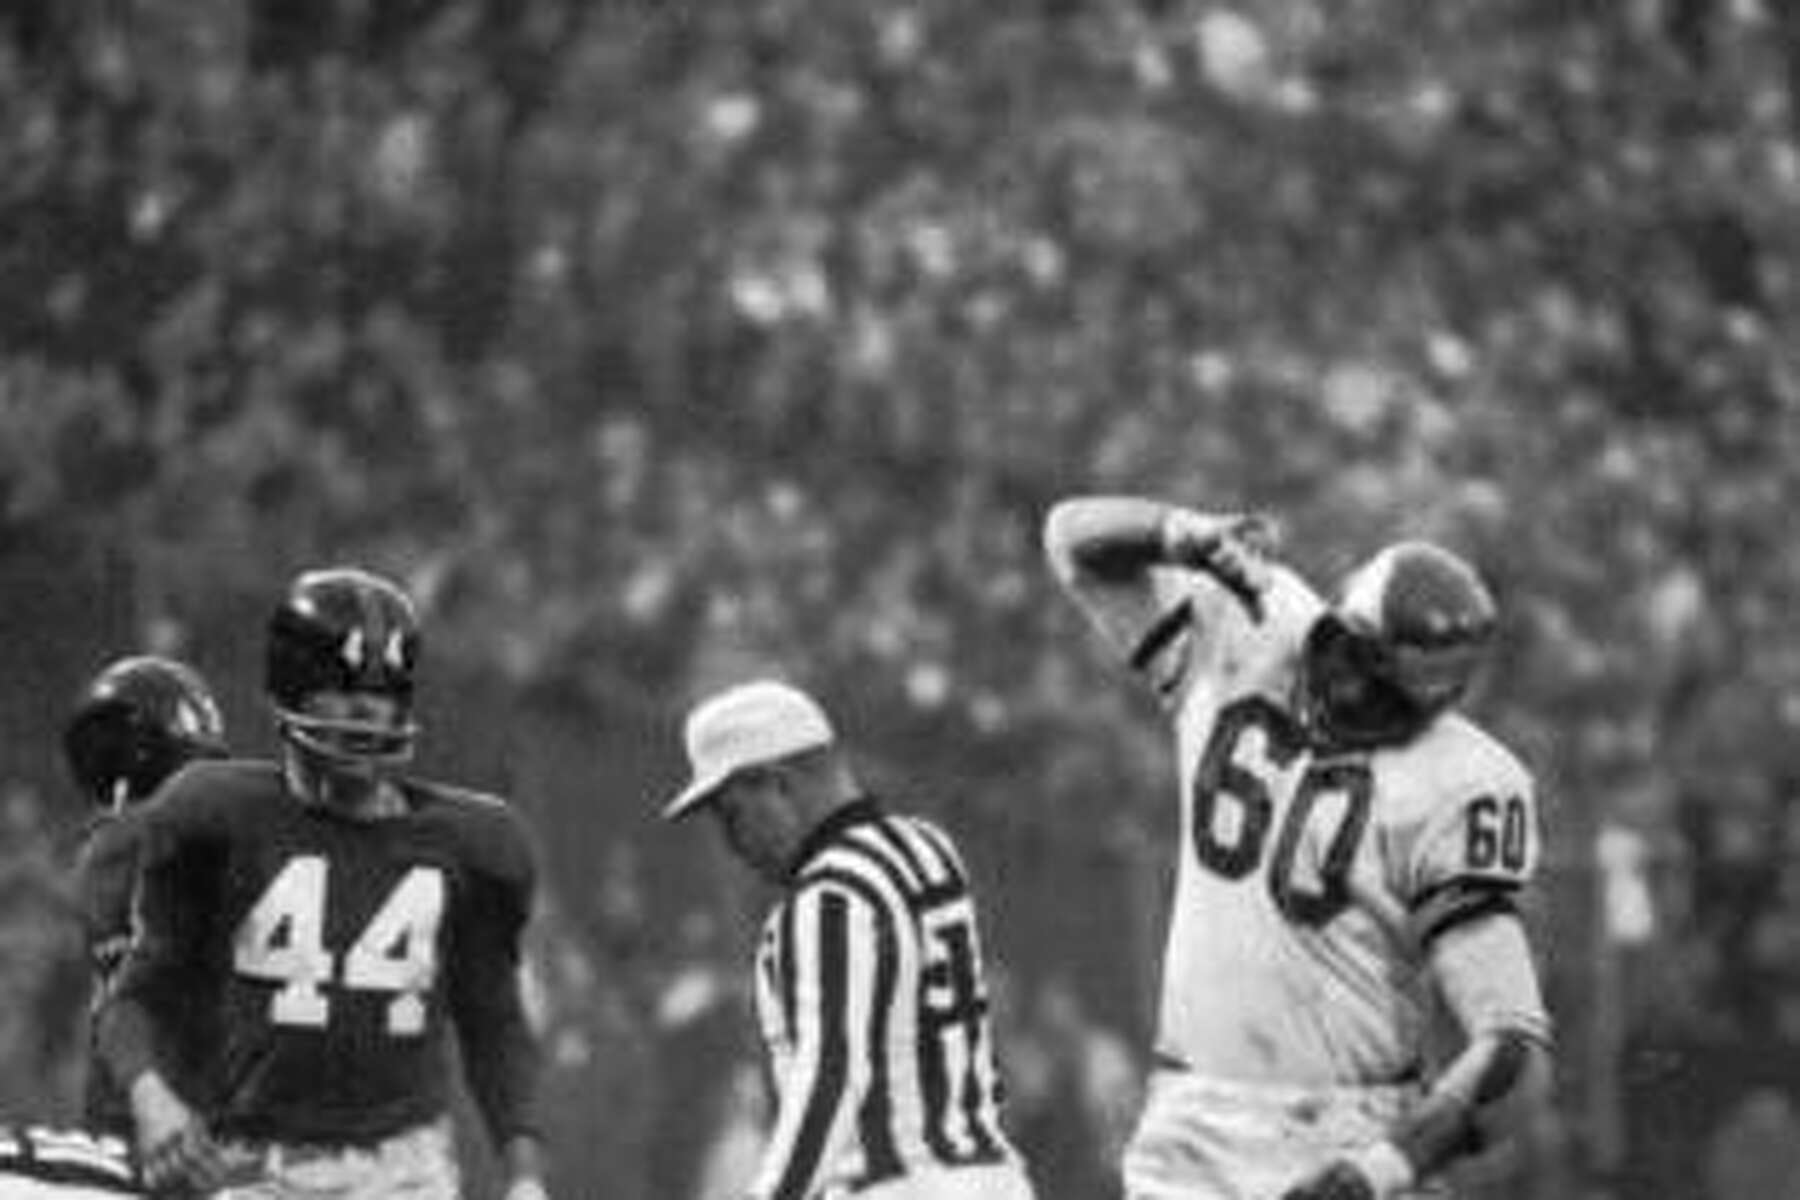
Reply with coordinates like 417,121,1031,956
446,808,542,1146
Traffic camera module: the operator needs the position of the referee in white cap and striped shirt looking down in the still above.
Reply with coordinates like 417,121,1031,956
662,680,1031,1200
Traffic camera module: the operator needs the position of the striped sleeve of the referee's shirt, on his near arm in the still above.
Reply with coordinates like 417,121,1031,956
751,880,893,1200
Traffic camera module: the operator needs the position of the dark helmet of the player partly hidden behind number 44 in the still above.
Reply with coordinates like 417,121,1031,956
63,655,225,808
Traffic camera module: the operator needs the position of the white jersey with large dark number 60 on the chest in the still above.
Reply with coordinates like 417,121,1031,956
1082,569,1548,1087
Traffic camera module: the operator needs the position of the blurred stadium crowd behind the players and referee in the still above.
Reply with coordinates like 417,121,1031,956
0,0,1800,1200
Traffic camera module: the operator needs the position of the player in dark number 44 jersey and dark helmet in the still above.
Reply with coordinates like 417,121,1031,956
101,567,545,1200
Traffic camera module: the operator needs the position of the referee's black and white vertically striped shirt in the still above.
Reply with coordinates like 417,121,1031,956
751,801,1015,1200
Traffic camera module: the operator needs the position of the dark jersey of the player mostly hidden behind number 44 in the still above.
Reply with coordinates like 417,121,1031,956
76,810,212,1135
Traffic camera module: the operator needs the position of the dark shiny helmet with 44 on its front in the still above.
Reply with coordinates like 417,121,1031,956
265,567,419,766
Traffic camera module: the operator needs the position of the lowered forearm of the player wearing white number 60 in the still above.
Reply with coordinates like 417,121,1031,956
1390,1029,1550,1178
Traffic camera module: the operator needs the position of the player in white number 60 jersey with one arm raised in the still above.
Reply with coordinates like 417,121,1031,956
1044,497,1550,1200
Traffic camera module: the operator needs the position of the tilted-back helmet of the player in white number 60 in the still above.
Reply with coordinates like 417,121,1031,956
1300,542,1498,747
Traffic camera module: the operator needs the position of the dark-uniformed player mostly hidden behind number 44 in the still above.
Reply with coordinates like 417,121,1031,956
63,655,225,1133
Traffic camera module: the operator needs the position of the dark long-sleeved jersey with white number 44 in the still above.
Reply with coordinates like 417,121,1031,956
101,761,536,1144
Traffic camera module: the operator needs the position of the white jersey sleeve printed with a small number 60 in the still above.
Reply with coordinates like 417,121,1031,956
1397,754,1543,945
